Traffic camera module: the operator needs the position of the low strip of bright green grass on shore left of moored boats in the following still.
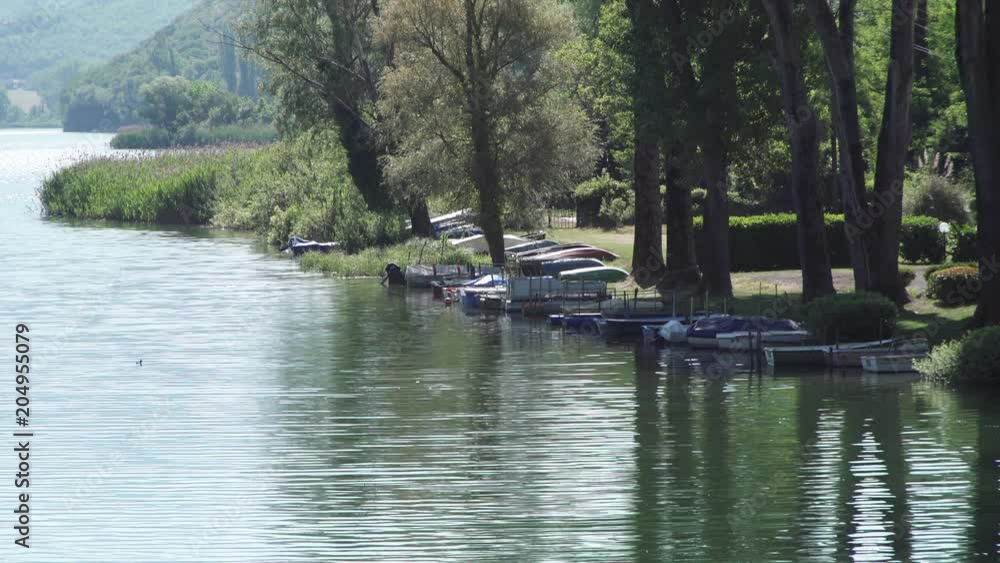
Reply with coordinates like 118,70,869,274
300,239,480,277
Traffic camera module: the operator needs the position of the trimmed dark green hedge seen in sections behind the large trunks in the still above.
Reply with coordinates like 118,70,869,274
694,213,946,272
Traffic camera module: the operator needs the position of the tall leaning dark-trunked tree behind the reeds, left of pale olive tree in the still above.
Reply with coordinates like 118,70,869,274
240,0,431,236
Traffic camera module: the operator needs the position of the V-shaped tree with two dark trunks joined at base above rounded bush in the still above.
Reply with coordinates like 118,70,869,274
806,0,914,301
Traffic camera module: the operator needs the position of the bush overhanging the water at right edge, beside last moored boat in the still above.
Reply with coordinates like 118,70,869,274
914,326,1000,385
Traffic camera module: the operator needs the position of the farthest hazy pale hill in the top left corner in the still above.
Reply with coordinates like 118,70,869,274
0,0,197,79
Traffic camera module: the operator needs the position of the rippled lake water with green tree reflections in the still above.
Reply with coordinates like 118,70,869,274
0,131,1000,562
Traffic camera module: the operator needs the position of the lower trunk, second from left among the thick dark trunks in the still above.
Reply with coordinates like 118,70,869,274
664,143,701,285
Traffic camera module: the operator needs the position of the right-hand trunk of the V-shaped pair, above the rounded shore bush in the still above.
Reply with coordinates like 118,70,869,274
870,0,914,304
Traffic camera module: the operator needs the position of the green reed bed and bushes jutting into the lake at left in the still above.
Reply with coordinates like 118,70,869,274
41,132,404,250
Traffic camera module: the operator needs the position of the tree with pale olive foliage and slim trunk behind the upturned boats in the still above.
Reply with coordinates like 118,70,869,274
378,0,596,263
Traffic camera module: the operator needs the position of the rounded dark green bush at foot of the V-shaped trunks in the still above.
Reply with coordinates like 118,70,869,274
807,293,898,344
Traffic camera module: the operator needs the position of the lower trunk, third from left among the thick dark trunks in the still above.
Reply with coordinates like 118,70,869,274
700,137,733,296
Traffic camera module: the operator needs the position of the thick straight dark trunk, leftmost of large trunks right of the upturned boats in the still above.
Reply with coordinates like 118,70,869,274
627,0,666,287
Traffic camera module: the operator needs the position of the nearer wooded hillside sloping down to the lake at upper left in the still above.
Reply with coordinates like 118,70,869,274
62,0,252,131
